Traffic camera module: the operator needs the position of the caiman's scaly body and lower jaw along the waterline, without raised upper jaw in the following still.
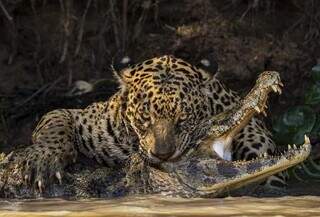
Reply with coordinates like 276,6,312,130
1,139,311,198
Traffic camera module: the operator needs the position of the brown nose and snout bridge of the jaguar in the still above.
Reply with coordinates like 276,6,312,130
150,120,176,160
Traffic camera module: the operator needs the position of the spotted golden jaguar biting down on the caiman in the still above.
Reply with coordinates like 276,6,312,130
0,55,285,191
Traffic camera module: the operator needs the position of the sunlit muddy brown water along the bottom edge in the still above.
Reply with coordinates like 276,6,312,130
0,196,320,217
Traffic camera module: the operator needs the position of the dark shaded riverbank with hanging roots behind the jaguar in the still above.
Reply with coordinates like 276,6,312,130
0,0,320,151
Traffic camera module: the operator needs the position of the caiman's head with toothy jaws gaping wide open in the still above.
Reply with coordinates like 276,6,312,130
151,72,311,196
